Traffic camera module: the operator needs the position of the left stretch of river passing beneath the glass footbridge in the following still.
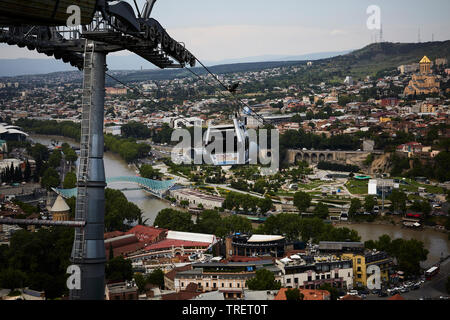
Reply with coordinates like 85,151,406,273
30,134,171,225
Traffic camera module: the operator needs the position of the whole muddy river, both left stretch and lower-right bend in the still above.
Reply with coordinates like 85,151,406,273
30,135,450,266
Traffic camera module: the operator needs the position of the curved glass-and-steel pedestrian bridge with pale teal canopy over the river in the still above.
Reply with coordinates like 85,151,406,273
52,177,176,199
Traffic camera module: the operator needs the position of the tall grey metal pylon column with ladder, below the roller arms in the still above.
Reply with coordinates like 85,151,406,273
70,40,106,300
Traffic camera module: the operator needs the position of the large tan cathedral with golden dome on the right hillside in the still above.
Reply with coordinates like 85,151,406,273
404,56,440,96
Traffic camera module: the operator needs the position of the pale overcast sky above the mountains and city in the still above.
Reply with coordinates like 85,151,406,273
0,0,450,61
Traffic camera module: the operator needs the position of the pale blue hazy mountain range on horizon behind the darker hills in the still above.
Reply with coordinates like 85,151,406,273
0,51,349,77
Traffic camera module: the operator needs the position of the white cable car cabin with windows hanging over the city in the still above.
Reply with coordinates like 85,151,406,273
203,118,255,166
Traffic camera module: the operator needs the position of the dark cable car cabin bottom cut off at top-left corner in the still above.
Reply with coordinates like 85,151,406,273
0,0,98,26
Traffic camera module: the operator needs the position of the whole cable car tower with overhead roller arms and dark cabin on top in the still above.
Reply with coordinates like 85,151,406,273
0,0,196,300
